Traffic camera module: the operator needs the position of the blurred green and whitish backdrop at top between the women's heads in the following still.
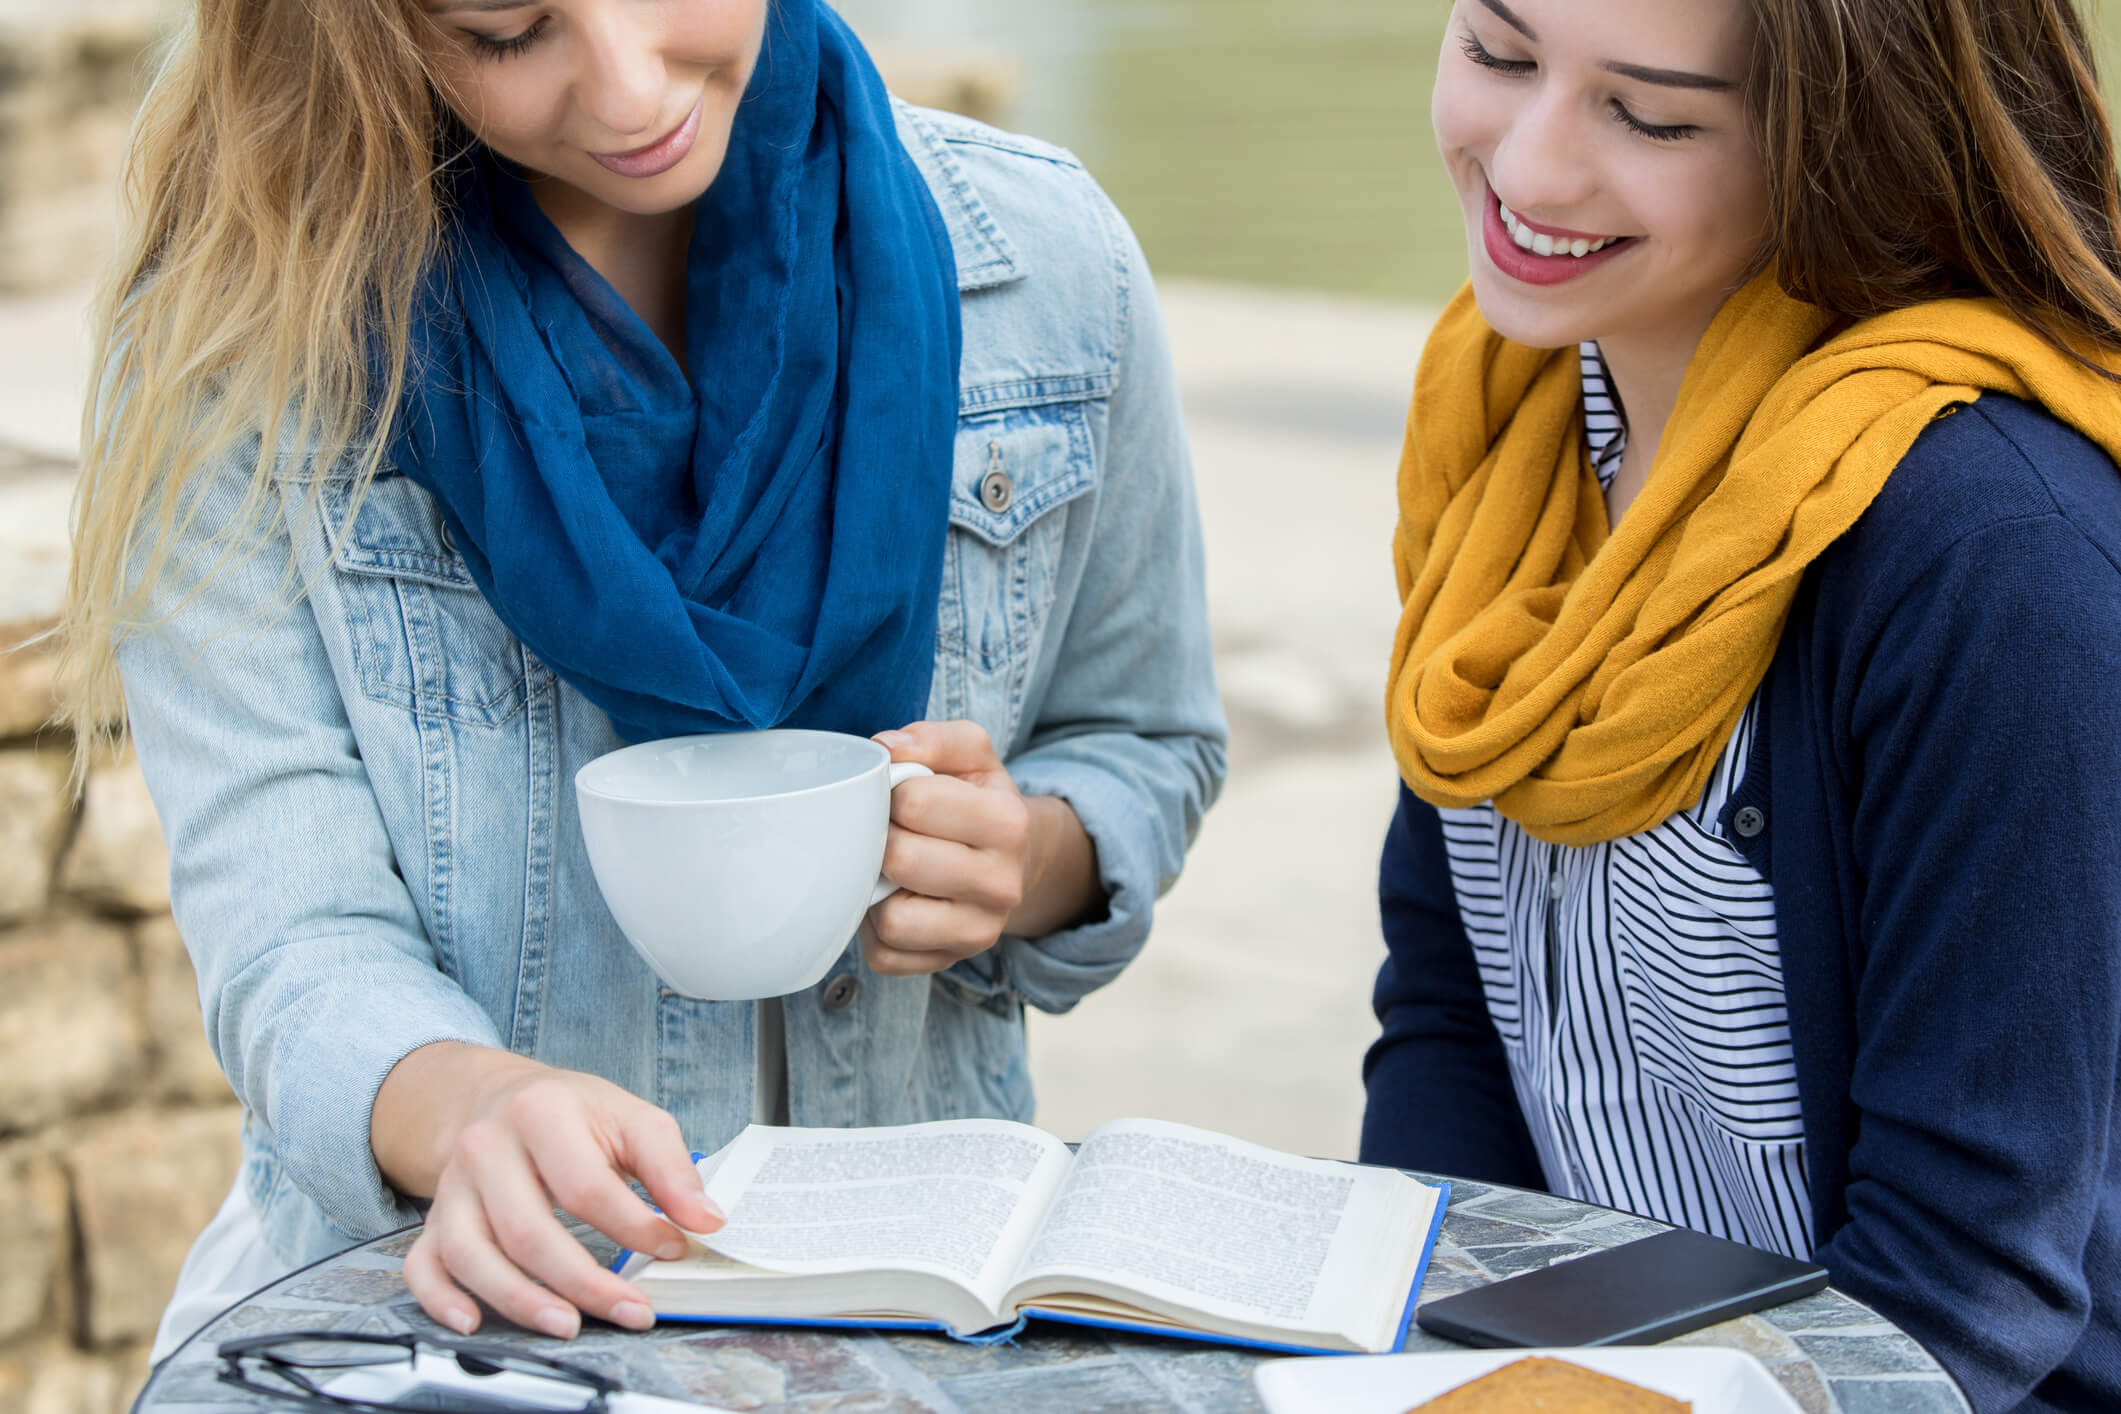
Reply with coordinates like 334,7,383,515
836,0,2121,303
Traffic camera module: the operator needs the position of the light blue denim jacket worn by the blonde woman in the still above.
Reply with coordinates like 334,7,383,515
119,108,1224,1263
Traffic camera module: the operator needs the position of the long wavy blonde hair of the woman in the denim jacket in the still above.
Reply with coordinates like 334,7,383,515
57,0,443,774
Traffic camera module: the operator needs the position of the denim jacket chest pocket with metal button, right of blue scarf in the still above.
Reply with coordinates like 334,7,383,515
935,401,1097,744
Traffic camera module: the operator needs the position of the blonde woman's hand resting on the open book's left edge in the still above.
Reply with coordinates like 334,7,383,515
371,1043,721,1338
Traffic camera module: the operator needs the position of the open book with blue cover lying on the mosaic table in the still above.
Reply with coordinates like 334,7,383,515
615,1119,1449,1353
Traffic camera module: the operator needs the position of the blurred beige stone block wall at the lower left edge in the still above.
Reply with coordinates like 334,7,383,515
0,452,238,1414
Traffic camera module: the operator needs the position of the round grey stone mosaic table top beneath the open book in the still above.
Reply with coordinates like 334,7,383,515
134,1181,1966,1414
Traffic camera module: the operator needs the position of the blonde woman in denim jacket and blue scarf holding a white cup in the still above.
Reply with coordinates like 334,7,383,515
68,0,1224,1353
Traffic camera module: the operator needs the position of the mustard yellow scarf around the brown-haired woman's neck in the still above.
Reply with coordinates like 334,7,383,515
1387,273,2121,844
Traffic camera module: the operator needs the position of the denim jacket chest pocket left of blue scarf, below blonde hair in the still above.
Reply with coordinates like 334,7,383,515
322,475,537,727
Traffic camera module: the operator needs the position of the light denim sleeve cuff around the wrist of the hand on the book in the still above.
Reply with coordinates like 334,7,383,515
252,939,501,1238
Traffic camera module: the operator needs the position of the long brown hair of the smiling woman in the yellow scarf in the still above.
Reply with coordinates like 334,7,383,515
1748,0,2121,360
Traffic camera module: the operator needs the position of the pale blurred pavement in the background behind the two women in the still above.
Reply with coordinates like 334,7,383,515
0,280,1432,1155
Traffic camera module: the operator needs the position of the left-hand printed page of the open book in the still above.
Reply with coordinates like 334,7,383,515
694,1119,1069,1308
